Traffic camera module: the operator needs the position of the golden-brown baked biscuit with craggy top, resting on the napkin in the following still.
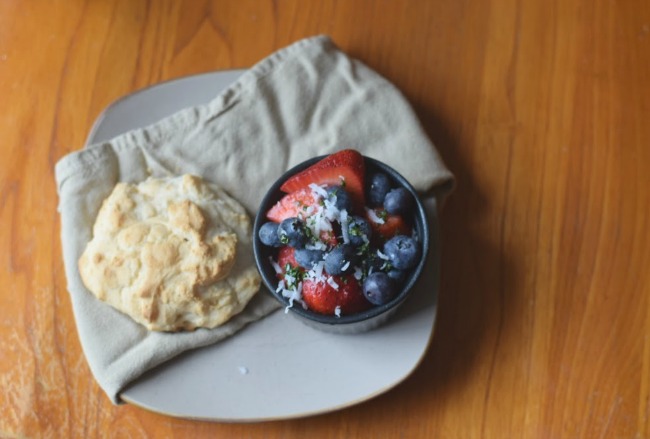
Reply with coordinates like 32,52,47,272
79,175,261,331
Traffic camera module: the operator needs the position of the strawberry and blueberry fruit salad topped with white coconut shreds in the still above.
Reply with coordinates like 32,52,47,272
258,149,422,317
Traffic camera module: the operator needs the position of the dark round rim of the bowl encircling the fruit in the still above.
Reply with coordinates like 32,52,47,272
253,154,430,326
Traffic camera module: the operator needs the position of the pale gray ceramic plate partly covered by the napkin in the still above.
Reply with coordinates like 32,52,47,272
87,71,439,422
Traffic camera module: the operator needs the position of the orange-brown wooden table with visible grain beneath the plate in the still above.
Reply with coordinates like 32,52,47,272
0,0,650,438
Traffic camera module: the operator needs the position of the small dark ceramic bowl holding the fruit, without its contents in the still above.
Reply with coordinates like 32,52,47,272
253,156,429,334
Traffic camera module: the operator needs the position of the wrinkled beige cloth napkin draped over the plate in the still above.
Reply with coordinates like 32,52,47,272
56,36,453,403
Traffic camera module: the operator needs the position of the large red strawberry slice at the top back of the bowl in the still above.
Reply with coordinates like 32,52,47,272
280,149,365,209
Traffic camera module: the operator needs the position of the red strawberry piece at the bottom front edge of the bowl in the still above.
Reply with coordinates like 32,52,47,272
302,275,372,315
